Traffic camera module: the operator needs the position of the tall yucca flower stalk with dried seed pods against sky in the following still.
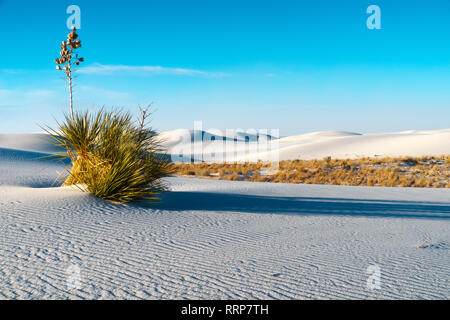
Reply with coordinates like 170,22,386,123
55,26,84,120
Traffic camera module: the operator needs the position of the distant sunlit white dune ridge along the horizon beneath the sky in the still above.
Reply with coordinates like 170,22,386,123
0,129,450,162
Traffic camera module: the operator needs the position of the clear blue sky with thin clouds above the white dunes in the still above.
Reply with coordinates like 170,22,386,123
0,0,450,135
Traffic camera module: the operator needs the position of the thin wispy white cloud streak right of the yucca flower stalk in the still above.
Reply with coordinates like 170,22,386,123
79,63,223,77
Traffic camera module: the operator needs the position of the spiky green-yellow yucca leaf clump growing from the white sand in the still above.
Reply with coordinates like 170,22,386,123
47,108,172,203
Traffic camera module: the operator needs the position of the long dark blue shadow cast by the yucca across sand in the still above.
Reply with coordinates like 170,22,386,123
141,191,450,220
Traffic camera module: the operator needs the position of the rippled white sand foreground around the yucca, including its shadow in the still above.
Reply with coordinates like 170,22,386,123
0,143,450,299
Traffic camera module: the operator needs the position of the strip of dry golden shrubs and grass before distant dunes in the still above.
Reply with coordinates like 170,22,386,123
171,156,450,188
